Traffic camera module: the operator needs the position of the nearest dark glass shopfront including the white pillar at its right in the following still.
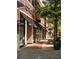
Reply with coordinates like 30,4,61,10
17,14,27,48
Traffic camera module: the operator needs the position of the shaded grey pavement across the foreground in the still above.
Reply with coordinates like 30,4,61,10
17,45,61,59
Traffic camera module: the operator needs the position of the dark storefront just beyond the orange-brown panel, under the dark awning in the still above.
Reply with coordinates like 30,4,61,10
33,22,45,43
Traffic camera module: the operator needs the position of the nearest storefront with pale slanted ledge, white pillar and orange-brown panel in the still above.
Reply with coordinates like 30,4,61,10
17,8,33,49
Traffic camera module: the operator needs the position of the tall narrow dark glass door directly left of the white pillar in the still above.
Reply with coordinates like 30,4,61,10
20,15,25,47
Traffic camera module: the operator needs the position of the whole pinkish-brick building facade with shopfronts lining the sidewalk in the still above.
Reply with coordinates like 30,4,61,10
17,0,45,49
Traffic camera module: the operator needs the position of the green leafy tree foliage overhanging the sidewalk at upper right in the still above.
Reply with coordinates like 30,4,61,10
36,0,61,31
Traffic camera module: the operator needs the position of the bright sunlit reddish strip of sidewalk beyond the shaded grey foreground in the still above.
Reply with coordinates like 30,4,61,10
26,43,53,48
